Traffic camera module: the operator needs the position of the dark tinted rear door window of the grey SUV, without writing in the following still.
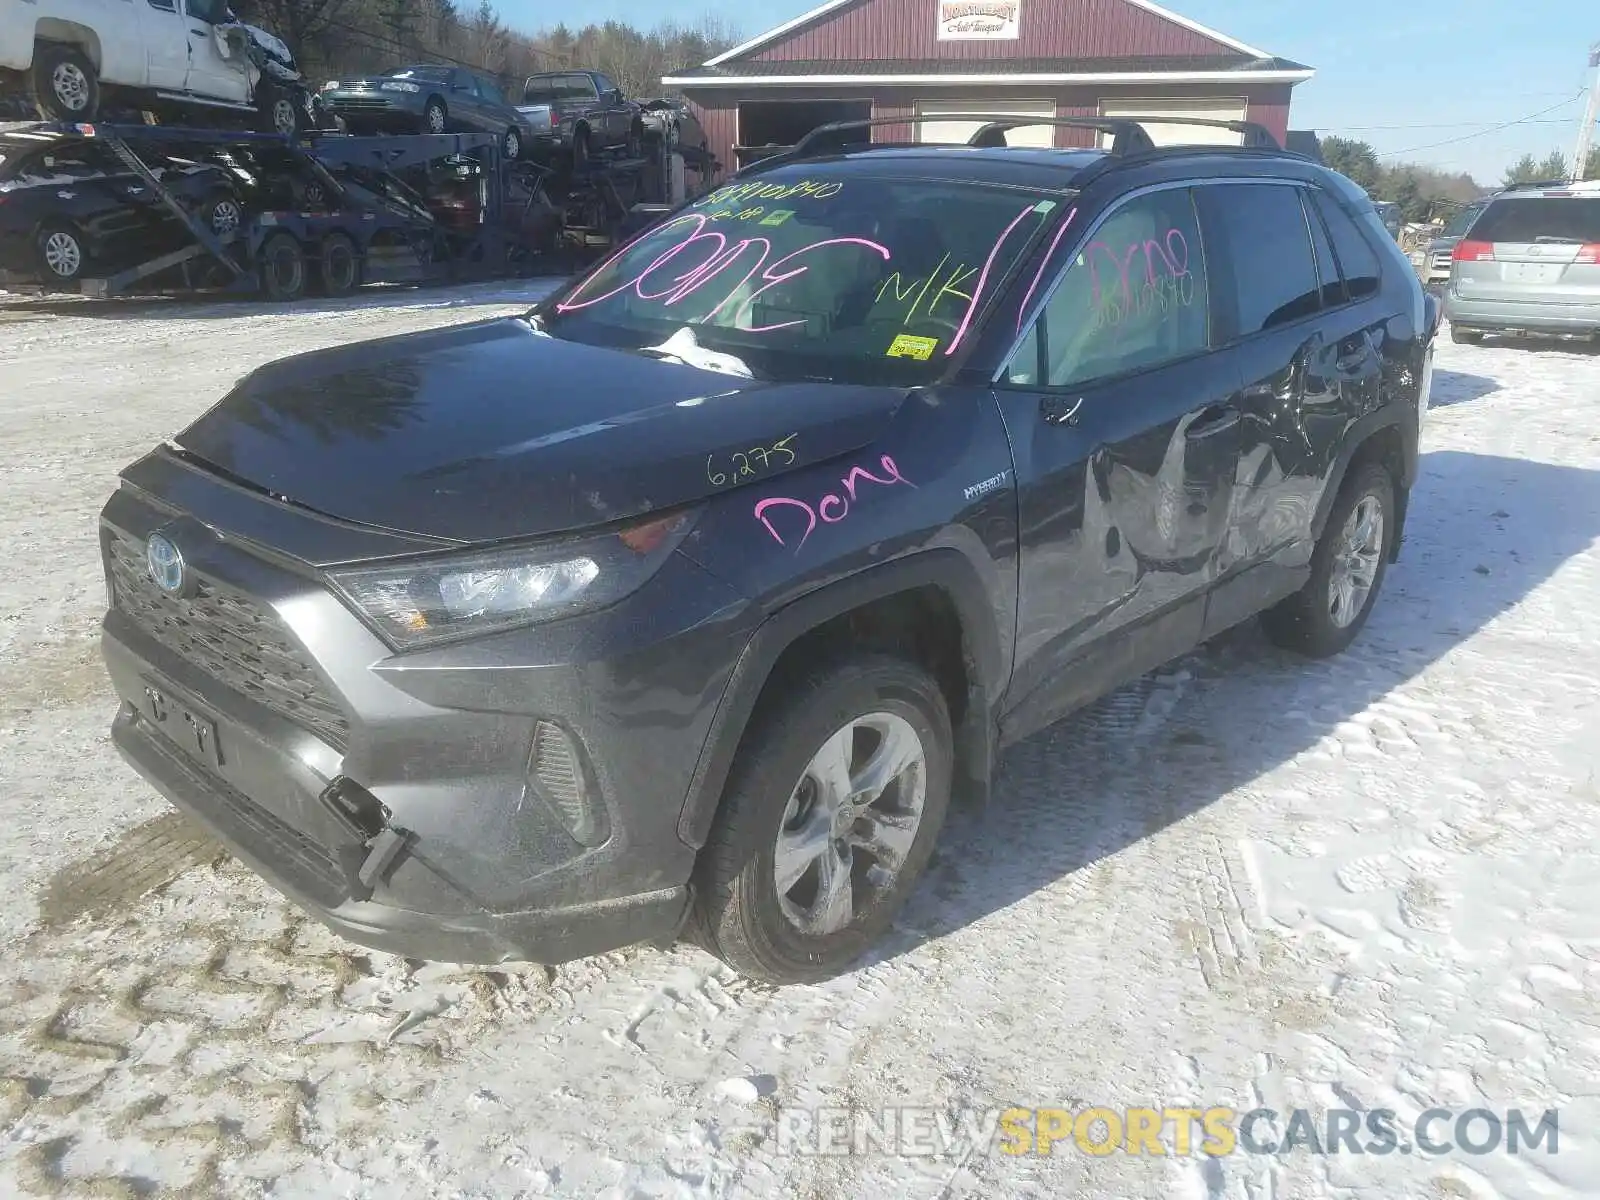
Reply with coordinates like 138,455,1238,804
1206,184,1322,338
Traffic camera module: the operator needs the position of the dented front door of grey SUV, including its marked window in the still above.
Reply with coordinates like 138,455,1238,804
997,187,1240,736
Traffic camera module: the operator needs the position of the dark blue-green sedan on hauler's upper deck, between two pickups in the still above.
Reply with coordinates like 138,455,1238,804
322,64,534,158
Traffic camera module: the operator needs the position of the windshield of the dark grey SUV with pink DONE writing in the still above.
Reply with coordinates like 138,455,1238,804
536,165,1061,384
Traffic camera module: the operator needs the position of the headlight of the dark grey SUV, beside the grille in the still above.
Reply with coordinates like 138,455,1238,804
328,512,694,650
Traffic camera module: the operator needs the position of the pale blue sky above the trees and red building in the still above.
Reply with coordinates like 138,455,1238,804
498,0,1600,184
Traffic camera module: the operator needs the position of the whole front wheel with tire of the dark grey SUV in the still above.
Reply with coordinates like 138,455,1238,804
694,656,954,984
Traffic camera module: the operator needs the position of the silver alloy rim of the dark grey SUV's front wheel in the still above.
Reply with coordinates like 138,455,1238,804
773,712,928,938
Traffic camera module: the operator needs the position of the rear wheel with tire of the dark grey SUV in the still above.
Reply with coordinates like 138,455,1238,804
1261,462,1397,658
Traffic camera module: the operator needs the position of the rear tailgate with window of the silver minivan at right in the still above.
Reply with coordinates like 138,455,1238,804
1453,187,1600,304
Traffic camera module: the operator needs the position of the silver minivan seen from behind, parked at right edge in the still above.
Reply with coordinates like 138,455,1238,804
1445,179,1600,342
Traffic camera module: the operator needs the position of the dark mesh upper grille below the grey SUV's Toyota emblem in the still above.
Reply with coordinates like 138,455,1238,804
107,531,350,752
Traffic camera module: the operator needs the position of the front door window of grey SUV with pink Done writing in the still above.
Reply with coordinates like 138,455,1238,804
1006,187,1210,387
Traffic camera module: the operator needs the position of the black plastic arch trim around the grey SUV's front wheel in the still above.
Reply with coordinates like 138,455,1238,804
678,549,1003,850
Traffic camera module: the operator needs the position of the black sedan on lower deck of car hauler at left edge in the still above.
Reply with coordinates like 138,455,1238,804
0,136,245,286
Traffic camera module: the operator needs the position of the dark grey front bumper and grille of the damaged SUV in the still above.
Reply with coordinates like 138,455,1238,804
102,459,747,963
